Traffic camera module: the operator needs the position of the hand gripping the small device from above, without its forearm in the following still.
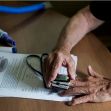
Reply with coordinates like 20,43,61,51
44,50,75,87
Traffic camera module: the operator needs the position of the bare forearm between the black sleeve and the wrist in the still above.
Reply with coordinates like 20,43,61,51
56,7,103,52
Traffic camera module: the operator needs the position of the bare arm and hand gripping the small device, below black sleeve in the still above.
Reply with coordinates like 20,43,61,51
45,6,104,86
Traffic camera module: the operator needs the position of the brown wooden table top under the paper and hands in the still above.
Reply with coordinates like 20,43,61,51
0,10,111,111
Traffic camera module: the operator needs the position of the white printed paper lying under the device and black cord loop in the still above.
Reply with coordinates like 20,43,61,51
0,52,77,101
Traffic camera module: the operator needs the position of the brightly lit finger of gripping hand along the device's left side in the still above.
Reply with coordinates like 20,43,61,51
49,57,62,82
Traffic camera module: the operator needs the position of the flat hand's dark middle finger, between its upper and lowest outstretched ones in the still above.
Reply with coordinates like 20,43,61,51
59,87,90,96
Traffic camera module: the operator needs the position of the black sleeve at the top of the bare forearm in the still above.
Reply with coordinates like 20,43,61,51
90,1,111,21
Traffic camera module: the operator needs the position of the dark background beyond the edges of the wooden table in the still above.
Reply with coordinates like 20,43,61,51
0,1,111,51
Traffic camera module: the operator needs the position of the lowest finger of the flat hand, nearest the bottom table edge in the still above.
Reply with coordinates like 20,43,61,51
67,94,94,106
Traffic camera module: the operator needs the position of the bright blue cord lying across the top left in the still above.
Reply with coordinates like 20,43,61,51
0,3,45,14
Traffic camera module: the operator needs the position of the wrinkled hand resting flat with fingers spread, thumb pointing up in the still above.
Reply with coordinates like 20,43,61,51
60,66,111,105
